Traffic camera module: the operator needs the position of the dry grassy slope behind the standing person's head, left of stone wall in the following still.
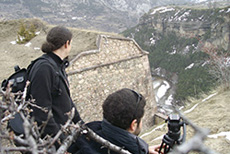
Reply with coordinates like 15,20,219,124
0,19,118,80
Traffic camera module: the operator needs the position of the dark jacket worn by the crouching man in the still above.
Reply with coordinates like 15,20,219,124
70,120,148,154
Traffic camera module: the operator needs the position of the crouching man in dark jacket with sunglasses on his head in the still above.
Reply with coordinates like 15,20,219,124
71,88,160,154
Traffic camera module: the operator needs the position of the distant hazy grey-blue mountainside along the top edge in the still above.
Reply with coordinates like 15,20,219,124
0,0,229,32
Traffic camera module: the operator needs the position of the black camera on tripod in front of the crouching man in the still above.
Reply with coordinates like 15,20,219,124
159,114,186,154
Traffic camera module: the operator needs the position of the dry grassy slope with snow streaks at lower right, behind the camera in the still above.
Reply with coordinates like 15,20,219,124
140,90,230,154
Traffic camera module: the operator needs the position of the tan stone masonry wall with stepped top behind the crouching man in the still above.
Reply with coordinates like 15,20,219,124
67,35,156,126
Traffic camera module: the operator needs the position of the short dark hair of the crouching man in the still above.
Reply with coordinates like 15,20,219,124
102,88,146,130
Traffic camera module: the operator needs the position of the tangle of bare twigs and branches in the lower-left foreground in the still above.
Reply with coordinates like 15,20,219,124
0,84,130,154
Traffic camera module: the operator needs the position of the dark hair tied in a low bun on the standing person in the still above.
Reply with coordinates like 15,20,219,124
42,26,72,53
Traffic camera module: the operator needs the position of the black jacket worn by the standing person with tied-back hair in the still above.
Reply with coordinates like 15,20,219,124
29,53,81,140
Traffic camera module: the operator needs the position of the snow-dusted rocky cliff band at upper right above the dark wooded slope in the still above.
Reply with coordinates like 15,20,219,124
140,7,230,50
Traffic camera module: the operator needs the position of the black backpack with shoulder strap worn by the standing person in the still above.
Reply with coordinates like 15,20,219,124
1,54,59,135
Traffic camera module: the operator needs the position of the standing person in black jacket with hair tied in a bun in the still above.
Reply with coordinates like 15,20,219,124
29,26,81,146
